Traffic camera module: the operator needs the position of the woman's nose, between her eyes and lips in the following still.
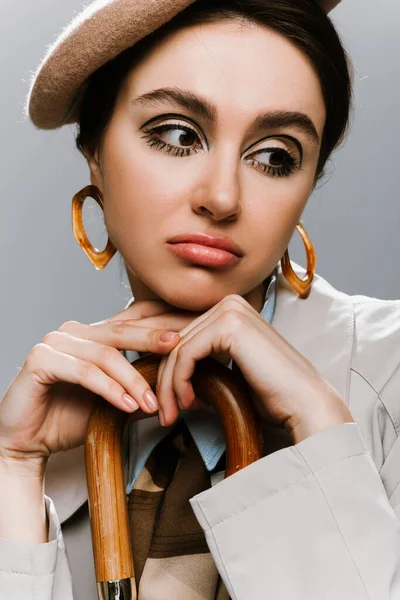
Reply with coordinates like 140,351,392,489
192,148,242,221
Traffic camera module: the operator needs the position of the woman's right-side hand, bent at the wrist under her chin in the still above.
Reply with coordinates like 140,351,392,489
126,294,353,443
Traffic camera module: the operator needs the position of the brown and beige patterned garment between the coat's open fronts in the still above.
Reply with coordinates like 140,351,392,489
128,419,230,600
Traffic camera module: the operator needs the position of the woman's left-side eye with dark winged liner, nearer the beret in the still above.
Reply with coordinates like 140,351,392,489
141,123,203,156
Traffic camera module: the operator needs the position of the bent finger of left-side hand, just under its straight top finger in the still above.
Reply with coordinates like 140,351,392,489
43,331,167,414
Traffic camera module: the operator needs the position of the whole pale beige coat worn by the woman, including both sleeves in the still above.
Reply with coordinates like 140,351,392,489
0,267,400,600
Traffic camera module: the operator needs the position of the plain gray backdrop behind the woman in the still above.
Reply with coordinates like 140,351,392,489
0,0,400,398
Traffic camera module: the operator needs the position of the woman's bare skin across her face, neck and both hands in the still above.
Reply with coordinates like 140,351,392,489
0,22,353,543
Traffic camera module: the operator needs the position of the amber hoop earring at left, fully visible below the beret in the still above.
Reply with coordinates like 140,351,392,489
72,185,117,270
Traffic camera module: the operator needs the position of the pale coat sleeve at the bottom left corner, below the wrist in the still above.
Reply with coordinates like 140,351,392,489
0,496,73,600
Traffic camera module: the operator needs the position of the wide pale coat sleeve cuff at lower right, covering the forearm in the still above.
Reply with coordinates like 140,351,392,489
191,423,400,600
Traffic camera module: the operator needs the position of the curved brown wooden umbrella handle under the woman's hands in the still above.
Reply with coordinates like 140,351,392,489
85,354,263,600
